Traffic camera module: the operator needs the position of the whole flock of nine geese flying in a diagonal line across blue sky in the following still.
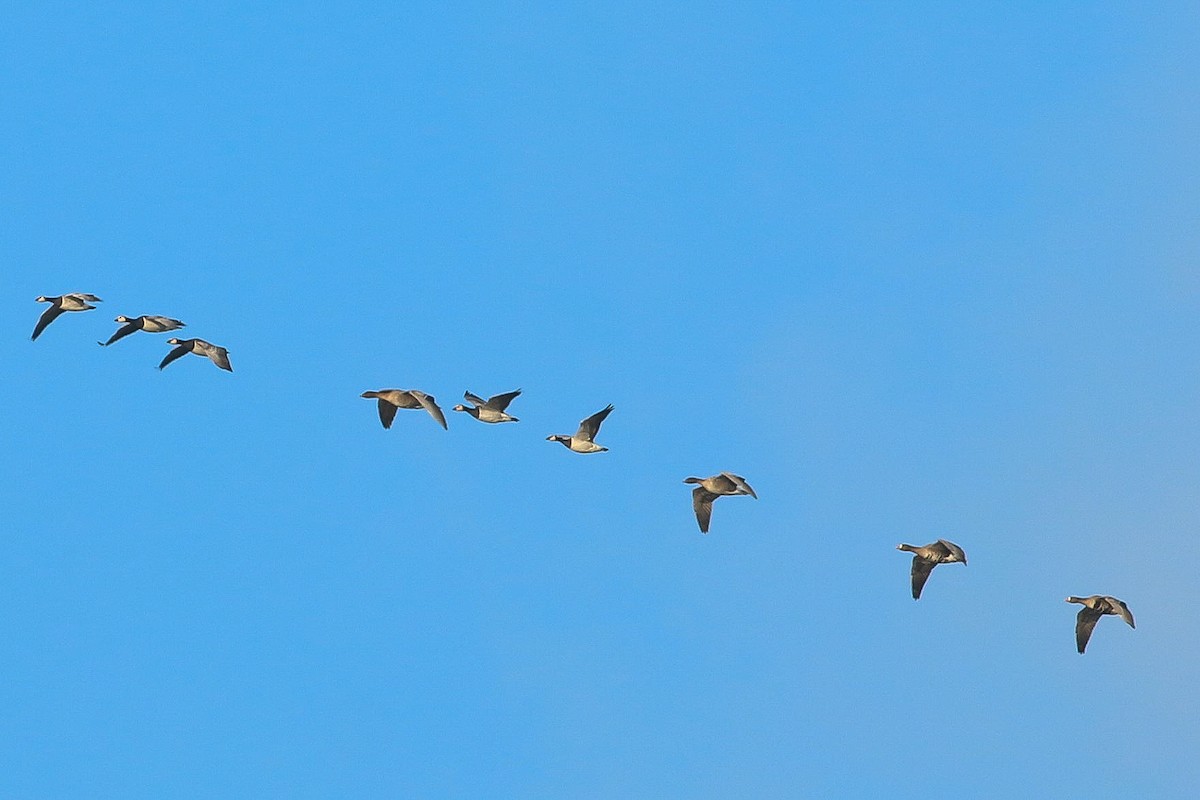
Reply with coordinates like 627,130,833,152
31,293,1134,652
